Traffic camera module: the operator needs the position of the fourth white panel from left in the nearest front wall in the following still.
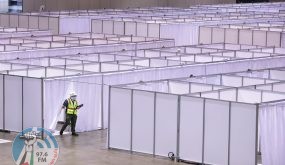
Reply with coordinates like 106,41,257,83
179,97,204,163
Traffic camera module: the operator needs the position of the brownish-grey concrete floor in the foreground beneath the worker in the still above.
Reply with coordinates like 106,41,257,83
0,130,184,165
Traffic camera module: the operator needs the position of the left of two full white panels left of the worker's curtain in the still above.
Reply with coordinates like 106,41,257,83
4,76,23,131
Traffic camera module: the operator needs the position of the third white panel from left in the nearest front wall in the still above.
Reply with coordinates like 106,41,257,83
155,94,178,156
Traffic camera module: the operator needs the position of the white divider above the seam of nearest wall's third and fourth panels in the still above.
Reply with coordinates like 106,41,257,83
168,81,189,94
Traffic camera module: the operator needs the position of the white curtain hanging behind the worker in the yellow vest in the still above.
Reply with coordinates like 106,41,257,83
44,76,102,132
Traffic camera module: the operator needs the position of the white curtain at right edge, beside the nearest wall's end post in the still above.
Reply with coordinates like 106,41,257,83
259,102,285,165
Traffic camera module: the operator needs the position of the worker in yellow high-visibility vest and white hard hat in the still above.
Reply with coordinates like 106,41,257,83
60,93,83,136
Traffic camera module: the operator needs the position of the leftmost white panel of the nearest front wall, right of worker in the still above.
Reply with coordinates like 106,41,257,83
109,88,132,150
